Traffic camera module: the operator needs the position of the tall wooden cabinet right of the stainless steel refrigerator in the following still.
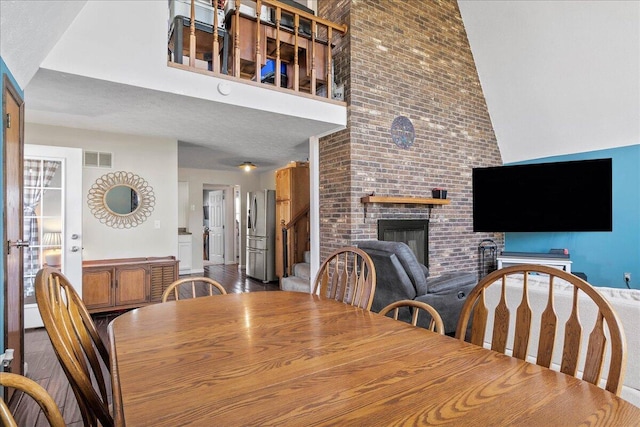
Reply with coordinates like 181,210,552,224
276,162,309,277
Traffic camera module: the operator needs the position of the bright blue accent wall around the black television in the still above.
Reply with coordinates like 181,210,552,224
505,145,640,289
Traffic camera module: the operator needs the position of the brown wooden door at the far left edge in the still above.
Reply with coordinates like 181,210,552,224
1,74,24,382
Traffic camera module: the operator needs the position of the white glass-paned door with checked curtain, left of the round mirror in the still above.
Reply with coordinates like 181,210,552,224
23,144,83,329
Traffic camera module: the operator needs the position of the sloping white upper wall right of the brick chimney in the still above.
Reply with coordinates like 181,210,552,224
458,0,640,163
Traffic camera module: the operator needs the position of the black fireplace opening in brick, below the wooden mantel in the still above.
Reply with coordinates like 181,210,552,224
378,219,429,267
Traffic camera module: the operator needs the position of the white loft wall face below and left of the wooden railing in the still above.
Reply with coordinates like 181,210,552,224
40,0,346,124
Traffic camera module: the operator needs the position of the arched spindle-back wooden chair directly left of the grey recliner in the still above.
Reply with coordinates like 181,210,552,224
313,247,376,310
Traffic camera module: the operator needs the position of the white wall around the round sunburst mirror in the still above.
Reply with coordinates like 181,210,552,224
25,123,178,260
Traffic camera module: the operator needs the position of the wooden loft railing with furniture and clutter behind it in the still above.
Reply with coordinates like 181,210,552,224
168,0,347,99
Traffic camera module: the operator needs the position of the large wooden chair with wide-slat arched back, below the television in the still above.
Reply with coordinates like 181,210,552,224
456,264,627,395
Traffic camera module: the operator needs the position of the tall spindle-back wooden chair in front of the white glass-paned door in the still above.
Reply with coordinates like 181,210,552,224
35,267,114,427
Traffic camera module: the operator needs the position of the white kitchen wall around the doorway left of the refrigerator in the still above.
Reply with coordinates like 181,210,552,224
178,168,276,272
